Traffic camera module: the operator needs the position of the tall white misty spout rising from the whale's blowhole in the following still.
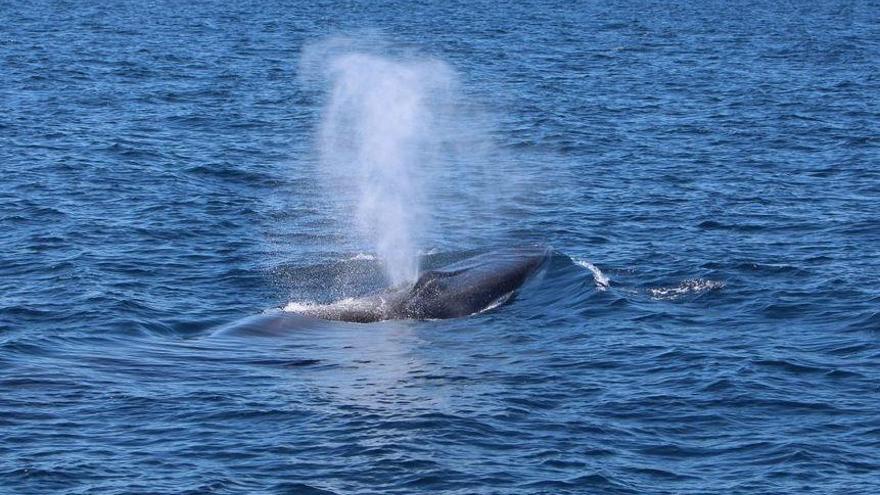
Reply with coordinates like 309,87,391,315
311,42,455,285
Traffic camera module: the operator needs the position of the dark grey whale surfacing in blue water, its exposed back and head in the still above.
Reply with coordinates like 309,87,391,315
222,246,552,335
